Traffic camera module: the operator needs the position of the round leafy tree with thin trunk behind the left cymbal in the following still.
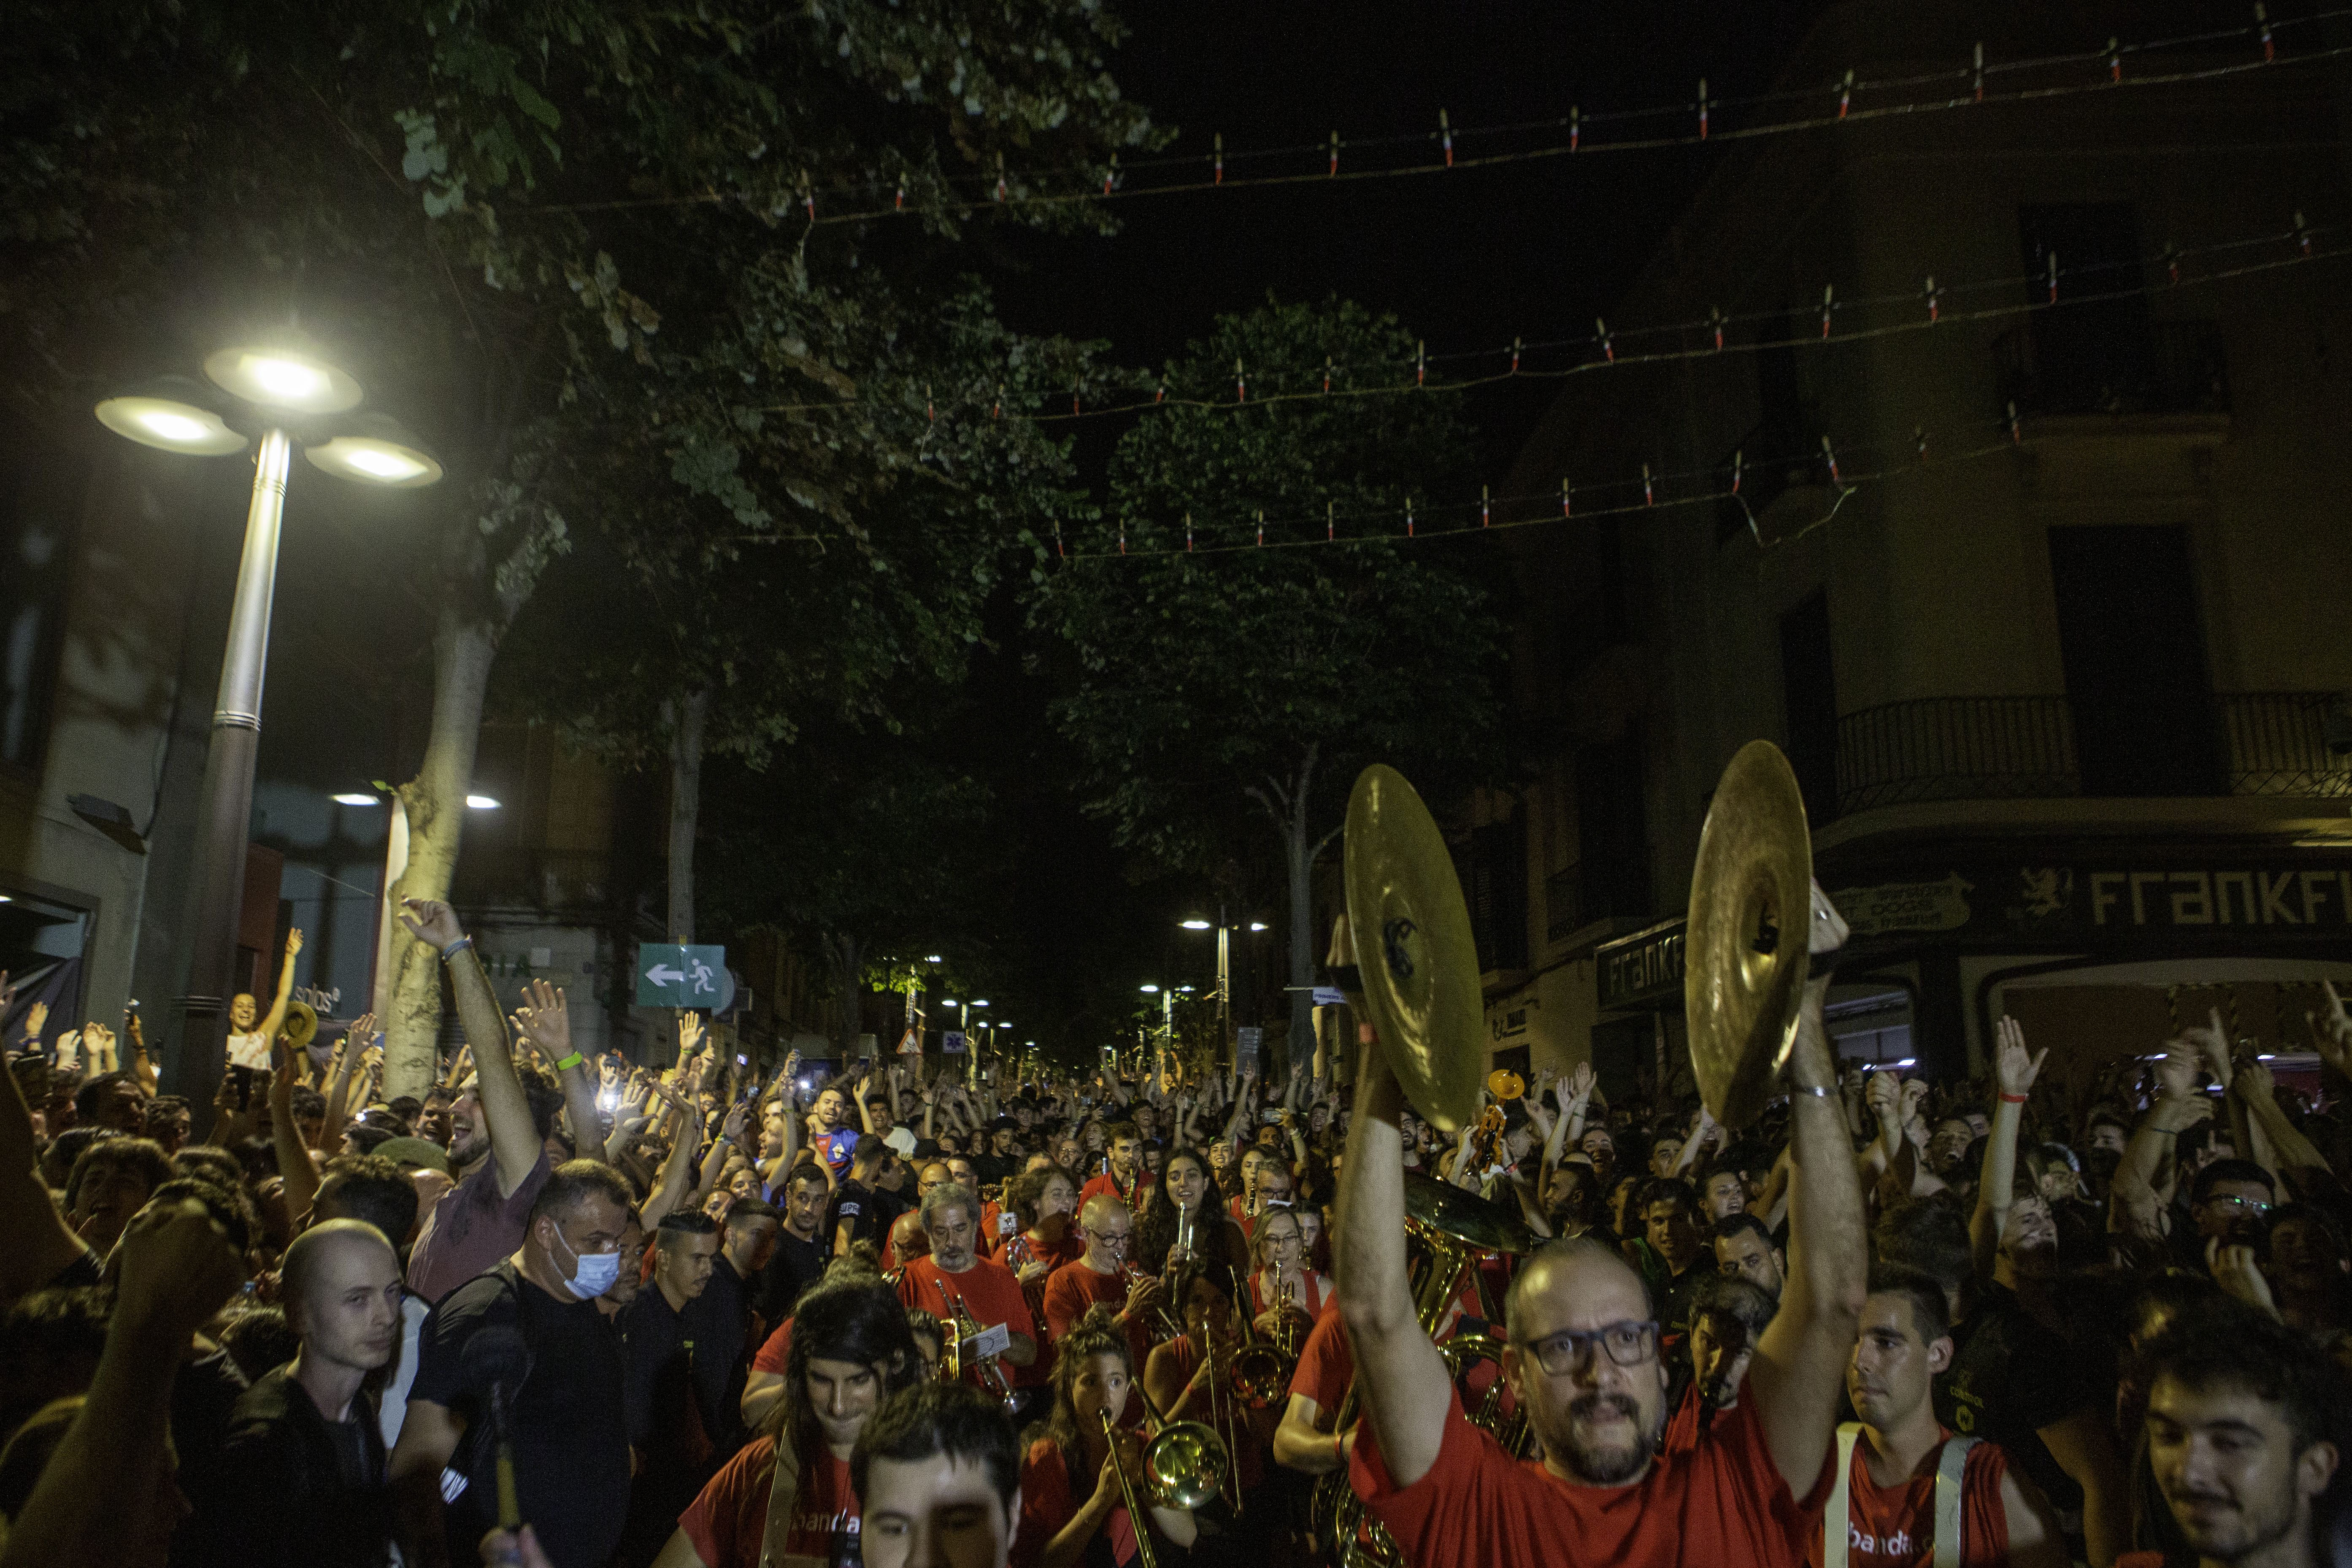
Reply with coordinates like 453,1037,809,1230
1033,301,1503,1053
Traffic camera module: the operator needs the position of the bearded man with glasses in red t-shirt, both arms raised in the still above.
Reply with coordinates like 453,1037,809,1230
1336,886,1868,1568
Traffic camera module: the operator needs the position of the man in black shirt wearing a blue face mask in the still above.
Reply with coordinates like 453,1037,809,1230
390,1159,633,1568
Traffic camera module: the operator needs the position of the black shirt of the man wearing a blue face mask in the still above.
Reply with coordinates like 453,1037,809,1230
409,1260,630,1565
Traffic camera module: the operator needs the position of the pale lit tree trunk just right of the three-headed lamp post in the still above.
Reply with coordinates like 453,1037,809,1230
381,600,496,1098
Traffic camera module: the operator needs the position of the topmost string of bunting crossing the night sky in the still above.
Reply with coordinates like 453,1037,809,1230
534,3,2352,228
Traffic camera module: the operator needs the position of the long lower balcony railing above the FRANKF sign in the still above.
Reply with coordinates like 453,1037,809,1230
1837,691,2352,814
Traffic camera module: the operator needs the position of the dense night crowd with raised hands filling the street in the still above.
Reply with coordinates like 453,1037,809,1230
0,891,2352,1568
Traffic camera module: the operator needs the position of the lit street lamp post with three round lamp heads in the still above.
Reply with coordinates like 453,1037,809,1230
97,343,442,1105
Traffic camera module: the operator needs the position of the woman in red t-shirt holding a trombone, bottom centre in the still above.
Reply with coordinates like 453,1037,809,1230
1011,1305,1195,1568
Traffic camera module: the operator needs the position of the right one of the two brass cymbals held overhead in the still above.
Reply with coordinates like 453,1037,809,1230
1682,741,1814,1131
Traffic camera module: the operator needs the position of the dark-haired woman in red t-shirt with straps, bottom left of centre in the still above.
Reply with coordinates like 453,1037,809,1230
654,1281,922,1568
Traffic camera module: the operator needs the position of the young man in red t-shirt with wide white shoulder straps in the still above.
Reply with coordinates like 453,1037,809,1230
1811,1263,2068,1568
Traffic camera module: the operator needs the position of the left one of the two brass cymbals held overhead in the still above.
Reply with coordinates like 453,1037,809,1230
1345,762,1487,1135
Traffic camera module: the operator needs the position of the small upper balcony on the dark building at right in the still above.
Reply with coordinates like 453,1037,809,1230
1992,315,2230,419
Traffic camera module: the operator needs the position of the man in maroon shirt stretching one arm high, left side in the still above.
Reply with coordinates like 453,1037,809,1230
400,898,574,1302
